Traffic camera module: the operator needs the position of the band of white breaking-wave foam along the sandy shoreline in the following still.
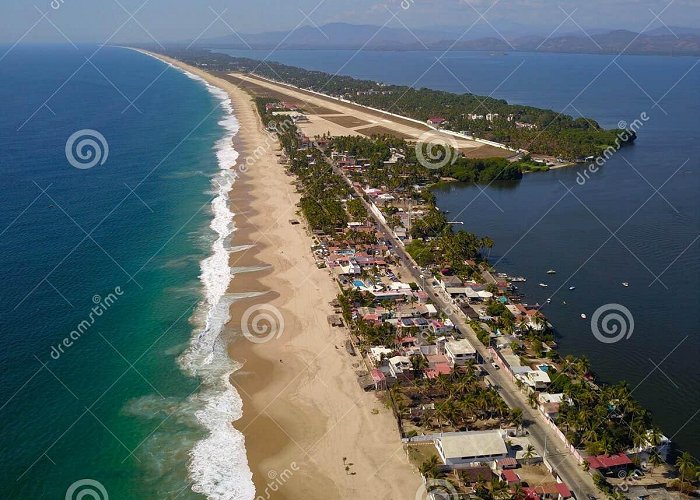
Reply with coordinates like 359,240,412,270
156,61,255,500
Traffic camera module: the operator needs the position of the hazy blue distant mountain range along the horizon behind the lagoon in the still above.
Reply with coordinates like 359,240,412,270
198,23,700,55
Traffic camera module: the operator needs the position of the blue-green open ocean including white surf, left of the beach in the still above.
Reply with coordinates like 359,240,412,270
0,45,253,498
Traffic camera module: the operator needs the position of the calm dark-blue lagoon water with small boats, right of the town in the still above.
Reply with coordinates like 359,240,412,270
222,50,700,457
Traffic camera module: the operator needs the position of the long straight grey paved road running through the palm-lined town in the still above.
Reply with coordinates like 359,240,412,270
329,160,600,499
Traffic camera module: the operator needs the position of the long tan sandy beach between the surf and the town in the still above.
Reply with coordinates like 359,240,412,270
142,51,421,499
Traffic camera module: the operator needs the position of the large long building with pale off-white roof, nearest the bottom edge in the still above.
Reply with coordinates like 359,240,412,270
435,430,508,467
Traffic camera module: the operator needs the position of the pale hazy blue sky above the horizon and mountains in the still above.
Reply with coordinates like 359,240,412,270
0,0,700,44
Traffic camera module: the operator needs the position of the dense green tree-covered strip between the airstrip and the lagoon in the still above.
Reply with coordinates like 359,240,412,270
168,51,635,160
